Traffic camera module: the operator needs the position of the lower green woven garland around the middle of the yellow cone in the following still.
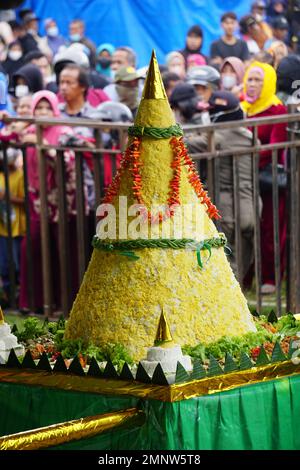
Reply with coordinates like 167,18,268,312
92,233,228,268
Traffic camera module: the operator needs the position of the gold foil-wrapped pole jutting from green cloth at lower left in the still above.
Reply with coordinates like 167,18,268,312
0,408,144,450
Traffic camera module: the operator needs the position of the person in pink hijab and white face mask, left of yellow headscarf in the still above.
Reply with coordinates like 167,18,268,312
220,57,245,101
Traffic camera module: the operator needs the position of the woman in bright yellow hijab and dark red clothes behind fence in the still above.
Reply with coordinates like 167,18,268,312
242,62,287,294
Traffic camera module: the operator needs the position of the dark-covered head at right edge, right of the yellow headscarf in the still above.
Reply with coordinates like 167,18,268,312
277,54,300,105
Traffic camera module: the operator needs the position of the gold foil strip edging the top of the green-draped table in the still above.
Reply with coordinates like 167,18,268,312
0,361,300,402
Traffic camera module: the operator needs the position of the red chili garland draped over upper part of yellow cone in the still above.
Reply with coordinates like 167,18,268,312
103,137,220,222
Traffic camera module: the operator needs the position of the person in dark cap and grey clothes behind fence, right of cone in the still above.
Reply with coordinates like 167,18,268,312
187,91,261,279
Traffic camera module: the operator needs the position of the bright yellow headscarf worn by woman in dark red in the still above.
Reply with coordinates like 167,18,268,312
241,61,281,116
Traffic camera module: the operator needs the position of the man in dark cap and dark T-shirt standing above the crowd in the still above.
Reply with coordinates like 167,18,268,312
210,12,249,64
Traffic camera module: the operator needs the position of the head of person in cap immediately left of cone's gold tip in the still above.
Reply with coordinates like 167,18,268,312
104,67,140,115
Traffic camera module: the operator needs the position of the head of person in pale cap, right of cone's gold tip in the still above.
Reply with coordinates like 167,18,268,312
186,65,221,103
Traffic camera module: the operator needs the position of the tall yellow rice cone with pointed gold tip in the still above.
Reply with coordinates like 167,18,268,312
66,50,255,360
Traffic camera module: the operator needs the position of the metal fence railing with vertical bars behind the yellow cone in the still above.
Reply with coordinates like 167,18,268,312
1,113,300,316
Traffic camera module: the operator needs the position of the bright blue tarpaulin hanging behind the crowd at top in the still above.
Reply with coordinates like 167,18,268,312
18,0,251,67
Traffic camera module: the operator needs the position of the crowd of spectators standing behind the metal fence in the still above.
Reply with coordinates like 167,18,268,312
0,0,300,310
